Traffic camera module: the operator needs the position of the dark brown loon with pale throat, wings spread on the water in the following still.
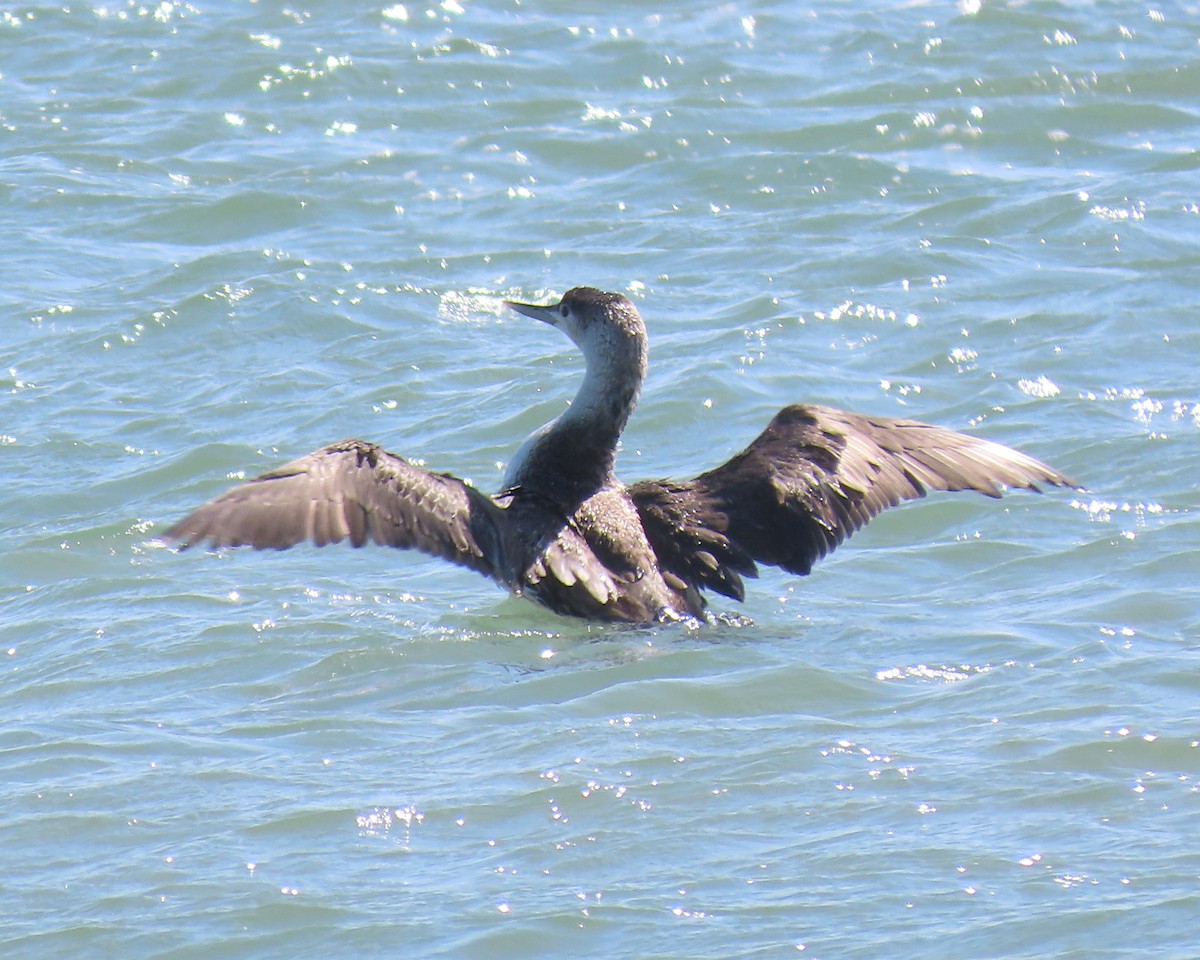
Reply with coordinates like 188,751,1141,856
163,287,1078,624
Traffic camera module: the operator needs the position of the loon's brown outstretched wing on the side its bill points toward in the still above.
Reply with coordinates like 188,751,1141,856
163,440,504,580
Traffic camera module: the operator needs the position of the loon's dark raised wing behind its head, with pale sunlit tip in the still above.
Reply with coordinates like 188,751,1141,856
629,404,1076,600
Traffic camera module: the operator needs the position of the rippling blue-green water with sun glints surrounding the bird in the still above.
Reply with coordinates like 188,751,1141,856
0,0,1200,959
